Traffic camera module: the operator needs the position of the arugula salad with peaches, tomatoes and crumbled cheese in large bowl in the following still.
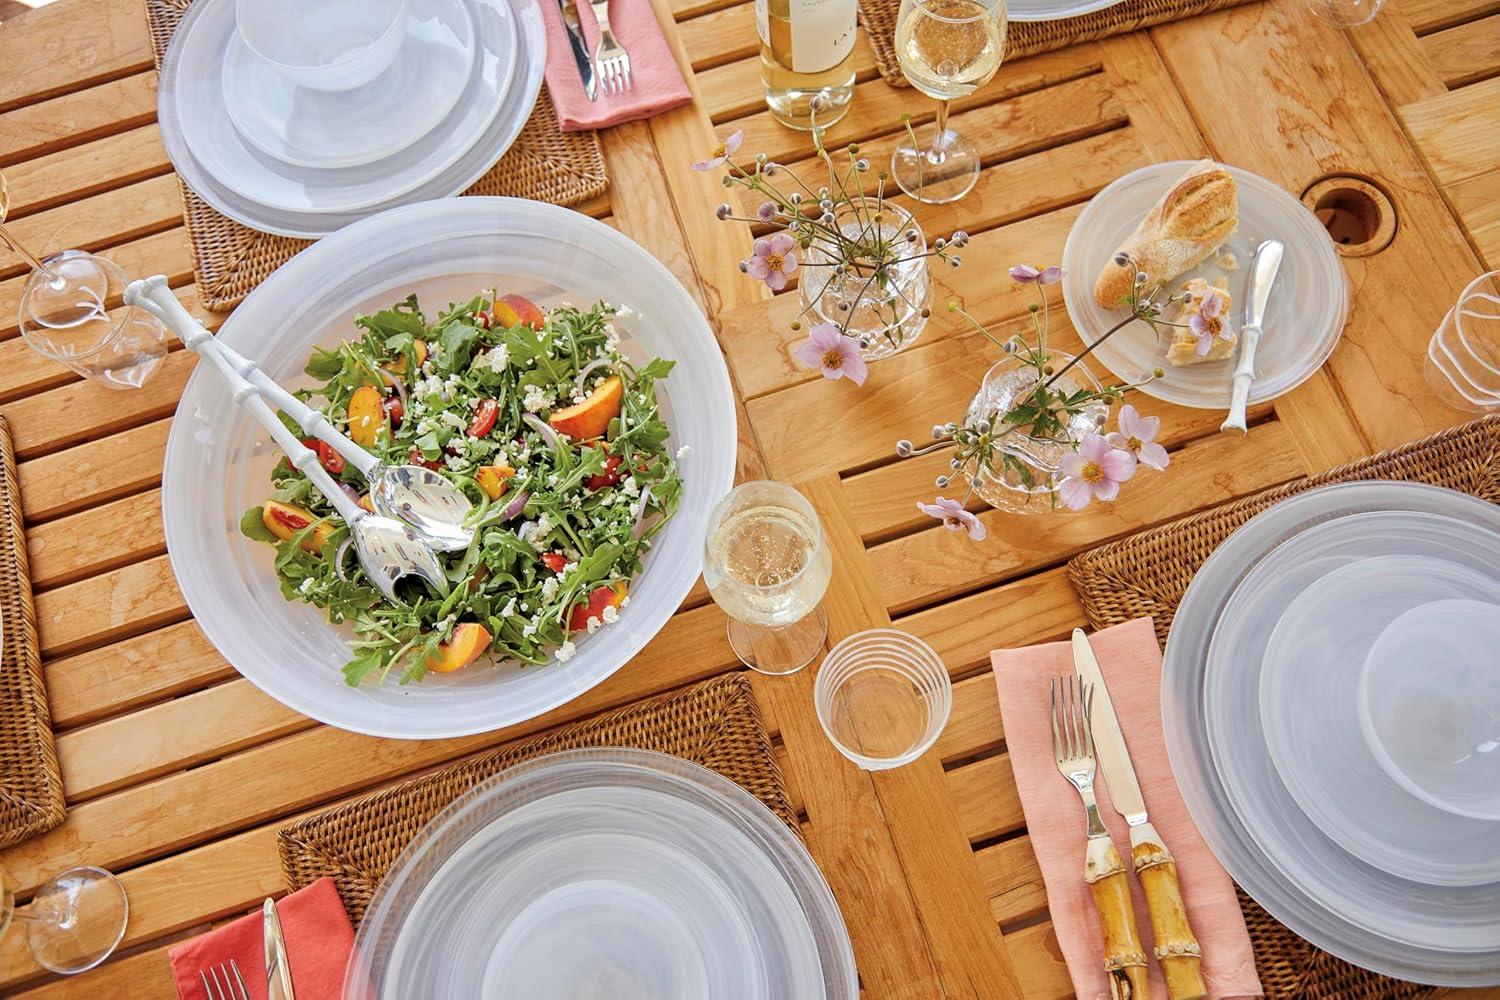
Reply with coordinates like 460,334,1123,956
240,289,683,685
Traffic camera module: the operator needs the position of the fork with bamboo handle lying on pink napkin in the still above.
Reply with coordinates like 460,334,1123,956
1050,676,1151,1000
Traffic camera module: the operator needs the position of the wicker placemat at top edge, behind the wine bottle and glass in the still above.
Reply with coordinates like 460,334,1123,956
860,0,1250,87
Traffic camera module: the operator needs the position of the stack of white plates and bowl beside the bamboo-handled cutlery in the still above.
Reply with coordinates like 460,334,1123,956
1163,481,1500,987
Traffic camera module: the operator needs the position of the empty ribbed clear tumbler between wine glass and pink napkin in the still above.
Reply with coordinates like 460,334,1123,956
813,628,953,771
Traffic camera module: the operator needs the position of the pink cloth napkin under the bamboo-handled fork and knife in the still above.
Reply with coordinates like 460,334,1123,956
990,618,1262,1000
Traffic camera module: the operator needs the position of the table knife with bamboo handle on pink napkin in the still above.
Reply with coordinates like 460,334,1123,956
1073,628,1208,1000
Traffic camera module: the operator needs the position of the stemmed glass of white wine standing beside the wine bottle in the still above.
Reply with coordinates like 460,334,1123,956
891,0,1005,204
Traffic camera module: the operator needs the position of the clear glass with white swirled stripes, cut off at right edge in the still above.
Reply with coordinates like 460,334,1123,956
1425,271,1500,411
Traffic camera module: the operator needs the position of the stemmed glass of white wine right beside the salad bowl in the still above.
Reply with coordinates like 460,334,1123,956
704,480,833,673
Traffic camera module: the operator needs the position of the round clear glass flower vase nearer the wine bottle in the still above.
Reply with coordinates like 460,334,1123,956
797,198,933,361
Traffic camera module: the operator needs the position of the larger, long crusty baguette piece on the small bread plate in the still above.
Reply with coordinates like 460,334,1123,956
1094,160,1239,309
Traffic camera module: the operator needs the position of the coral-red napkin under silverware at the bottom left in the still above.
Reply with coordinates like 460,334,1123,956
170,879,354,1000
